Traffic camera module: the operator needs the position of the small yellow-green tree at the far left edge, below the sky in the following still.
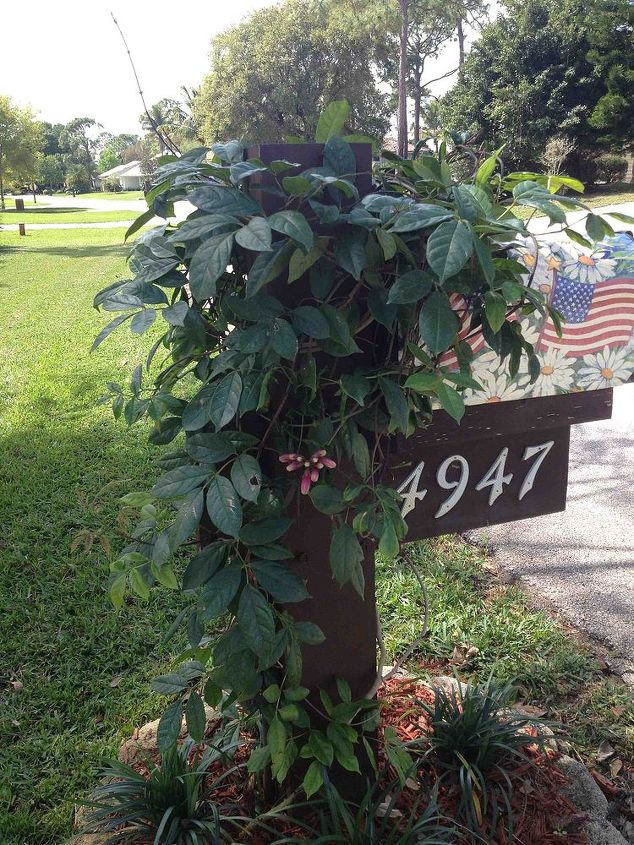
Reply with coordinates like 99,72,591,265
0,96,43,208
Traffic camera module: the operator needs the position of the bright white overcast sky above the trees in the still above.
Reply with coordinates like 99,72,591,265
0,0,470,134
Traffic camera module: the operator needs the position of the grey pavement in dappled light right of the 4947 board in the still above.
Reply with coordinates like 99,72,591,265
471,384,634,682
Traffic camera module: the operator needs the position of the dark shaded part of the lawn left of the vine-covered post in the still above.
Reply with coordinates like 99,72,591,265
0,416,182,845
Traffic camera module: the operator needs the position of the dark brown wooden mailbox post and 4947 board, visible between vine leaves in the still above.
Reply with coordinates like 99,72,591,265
242,144,612,698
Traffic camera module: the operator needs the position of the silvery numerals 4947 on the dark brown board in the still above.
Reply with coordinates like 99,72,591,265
397,440,555,519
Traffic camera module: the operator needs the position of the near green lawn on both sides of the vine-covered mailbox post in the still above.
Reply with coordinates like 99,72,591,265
0,229,634,845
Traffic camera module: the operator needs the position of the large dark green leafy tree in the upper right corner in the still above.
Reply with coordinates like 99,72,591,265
442,0,632,168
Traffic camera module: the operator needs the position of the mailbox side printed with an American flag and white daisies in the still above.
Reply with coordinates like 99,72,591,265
441,233,634,405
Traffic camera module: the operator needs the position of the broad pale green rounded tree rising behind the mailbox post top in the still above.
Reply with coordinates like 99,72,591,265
194,0,395,142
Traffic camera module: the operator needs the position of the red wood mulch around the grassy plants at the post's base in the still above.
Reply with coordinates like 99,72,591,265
116,678,586,845
